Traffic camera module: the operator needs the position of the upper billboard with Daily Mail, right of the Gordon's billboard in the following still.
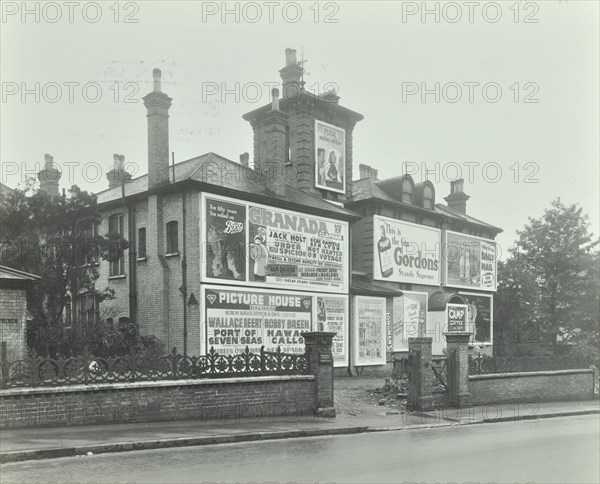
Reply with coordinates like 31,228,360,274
443,230,497,291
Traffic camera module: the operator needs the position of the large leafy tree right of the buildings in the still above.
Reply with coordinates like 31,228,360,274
495,198,600,356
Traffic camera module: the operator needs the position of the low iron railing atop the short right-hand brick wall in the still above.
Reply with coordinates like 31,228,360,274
469,354,591,375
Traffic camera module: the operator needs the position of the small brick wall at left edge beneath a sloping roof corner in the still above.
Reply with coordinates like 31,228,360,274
0,287,27,360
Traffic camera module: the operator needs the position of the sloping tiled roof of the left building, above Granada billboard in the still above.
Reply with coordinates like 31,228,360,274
96,153,356,217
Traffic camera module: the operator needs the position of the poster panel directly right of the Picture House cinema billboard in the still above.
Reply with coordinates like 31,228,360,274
314,296,348,366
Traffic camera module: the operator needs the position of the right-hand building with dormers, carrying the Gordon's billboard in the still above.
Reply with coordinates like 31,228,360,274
345,165,502,366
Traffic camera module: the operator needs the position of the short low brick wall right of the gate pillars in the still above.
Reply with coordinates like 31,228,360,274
469,370,594,405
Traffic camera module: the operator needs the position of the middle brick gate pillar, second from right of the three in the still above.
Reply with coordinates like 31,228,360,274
408,337,433,410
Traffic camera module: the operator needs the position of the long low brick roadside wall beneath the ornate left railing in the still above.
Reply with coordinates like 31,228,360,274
0,375,316,428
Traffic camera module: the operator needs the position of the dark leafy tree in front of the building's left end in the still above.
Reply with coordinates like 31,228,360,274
0,181,127,352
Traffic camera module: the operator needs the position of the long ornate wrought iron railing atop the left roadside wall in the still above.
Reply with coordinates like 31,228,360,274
0,347,307,388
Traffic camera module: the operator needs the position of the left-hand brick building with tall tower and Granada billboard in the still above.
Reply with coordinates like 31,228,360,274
85,49,362,366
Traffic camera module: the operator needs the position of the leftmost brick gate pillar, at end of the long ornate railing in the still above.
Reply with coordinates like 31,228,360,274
302,331,336,417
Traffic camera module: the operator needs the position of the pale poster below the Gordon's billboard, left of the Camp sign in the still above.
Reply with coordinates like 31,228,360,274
393,291,428,351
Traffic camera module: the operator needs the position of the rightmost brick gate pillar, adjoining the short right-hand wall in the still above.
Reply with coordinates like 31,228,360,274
444,332,471,407
